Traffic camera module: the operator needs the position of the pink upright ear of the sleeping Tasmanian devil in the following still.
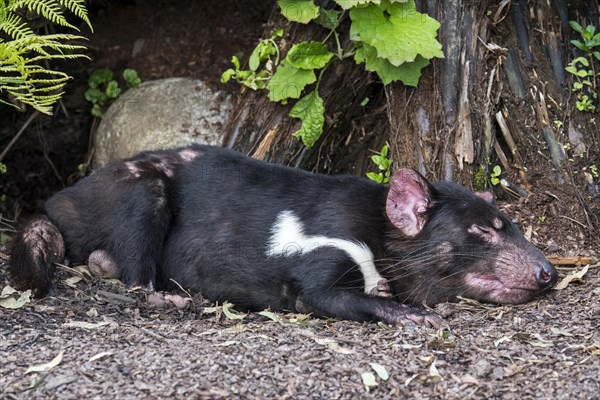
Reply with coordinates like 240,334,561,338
385,169,431,236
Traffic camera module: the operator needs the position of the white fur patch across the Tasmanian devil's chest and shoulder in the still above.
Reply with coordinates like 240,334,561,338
267,210,383,293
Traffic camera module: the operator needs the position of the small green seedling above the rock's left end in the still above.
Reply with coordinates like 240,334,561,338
84,68,142,118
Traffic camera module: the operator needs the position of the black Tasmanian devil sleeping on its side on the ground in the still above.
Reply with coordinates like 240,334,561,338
9,146,557,325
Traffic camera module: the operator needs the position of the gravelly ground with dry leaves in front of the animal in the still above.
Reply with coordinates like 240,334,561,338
0,254,600,399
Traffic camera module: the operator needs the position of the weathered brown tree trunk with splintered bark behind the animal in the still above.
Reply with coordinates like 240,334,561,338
223,0,600,237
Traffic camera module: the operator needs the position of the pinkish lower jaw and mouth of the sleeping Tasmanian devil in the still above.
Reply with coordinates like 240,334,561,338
465,274,540,304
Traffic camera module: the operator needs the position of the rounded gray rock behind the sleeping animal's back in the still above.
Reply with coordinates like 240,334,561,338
92,78,232,168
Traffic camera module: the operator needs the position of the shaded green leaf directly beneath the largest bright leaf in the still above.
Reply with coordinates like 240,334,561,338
354,43,429,86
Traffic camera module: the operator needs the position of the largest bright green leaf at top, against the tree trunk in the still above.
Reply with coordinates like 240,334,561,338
350,1,444,66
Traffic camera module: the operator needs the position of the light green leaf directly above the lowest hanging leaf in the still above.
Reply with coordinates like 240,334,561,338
267,61,317,101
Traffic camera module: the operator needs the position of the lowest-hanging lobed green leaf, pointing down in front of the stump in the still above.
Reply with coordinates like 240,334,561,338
290,90,325,148
